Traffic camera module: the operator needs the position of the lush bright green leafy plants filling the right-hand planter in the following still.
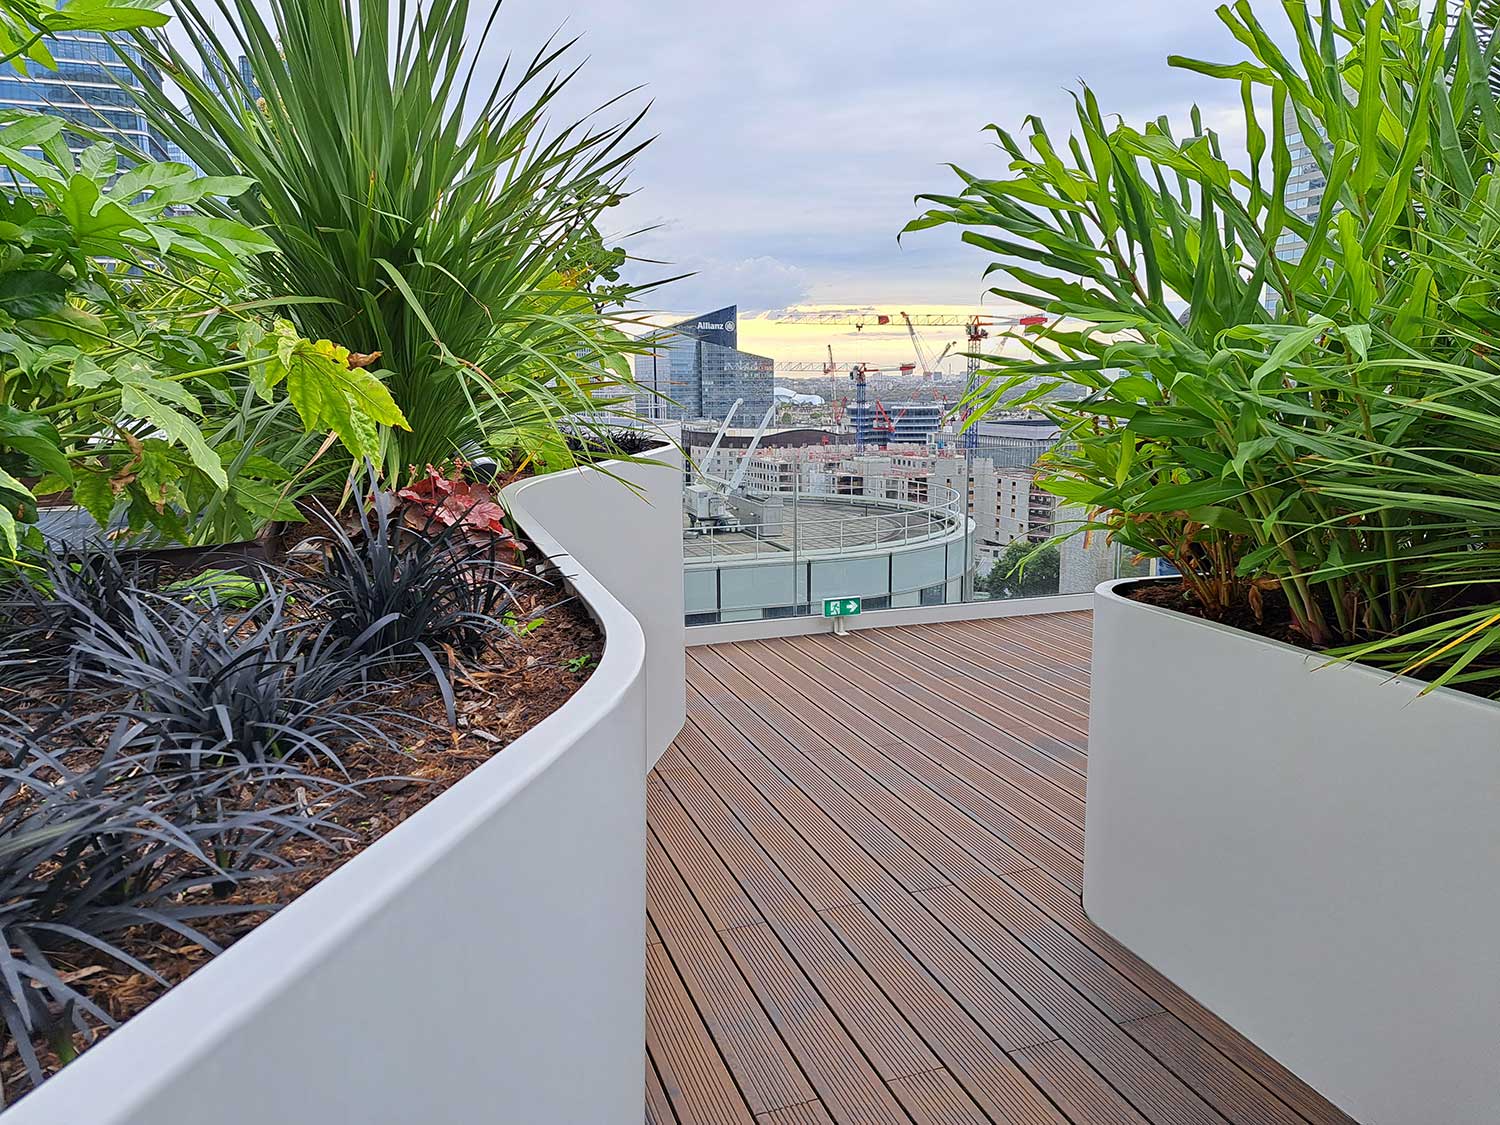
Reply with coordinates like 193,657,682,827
908,0,1500,693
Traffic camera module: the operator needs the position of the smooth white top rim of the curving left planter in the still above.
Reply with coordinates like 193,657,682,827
0,456,645,1125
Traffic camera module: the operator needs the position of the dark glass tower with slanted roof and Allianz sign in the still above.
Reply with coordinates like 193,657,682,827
635,305,776,426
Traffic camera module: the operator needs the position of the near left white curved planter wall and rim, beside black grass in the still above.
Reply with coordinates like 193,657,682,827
0,459,657,1125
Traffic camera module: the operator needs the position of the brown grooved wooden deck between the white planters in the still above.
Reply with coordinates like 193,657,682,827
645,614,1350,1125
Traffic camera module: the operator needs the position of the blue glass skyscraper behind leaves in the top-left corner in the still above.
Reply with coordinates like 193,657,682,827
0,32,171,166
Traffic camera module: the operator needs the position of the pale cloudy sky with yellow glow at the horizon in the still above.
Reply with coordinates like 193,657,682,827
193,0,1284,375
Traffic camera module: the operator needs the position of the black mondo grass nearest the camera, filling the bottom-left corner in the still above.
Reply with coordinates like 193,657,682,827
0,729,351,1104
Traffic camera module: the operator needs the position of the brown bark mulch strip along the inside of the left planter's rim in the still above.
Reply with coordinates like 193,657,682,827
0,549,603,1100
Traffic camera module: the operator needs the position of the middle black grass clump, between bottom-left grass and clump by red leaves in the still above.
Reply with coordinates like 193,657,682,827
71,582,407,771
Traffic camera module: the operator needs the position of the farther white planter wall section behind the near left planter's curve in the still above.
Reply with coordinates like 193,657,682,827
504,444,687,767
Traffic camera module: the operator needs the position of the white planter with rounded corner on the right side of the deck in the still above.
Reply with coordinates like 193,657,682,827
1083,582,1500,1125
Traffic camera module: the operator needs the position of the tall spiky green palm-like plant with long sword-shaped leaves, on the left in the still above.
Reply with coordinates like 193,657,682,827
140,0,660,479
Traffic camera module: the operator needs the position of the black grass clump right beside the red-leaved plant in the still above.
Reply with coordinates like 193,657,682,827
297,491,521,723
